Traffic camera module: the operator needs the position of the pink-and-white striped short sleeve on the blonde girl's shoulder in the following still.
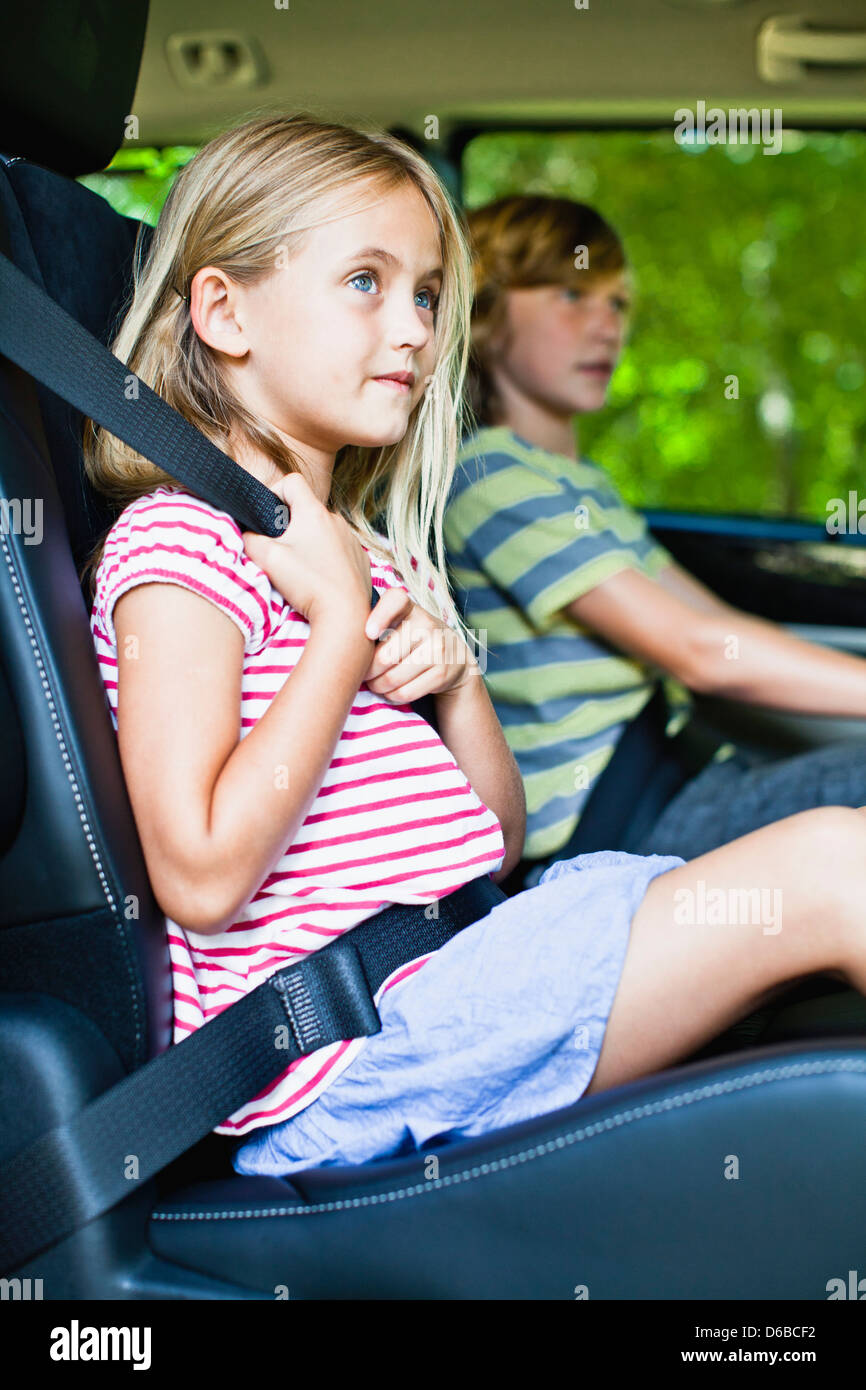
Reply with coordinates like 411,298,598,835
95,492,271,652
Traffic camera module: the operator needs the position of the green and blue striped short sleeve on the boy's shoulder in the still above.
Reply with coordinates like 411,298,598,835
446,455,670,631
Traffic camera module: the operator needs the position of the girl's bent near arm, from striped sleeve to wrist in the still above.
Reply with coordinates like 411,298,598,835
114,584,374,934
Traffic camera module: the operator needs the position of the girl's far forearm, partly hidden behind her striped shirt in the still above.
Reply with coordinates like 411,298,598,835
434,670,527,883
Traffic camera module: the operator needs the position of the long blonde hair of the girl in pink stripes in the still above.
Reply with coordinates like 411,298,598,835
82,113,475,651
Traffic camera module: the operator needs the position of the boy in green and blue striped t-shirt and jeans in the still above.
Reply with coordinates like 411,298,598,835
445,195,866,891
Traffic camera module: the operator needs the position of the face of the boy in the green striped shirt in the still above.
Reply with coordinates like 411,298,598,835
491,271,630,417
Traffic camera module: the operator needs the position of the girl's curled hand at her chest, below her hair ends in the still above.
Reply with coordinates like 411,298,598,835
364,588,480,705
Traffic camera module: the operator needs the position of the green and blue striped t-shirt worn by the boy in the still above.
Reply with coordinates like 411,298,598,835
445,425,689,859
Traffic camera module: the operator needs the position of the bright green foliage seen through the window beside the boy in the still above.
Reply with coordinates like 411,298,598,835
464,131,866,521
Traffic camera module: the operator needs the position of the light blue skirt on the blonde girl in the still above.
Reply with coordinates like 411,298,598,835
234,849,685,1177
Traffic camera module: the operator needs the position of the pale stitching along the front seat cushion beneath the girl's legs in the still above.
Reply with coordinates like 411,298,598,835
150,1058,866,1220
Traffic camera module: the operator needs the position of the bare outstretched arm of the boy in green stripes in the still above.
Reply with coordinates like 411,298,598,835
564,570,866,719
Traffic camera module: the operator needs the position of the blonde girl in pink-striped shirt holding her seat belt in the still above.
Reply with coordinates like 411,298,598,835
88,115,866,1175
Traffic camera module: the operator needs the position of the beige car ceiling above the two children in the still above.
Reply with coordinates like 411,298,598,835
133,0,866,145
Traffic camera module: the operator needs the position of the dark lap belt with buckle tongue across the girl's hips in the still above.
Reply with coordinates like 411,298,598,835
0,876,506,1275
